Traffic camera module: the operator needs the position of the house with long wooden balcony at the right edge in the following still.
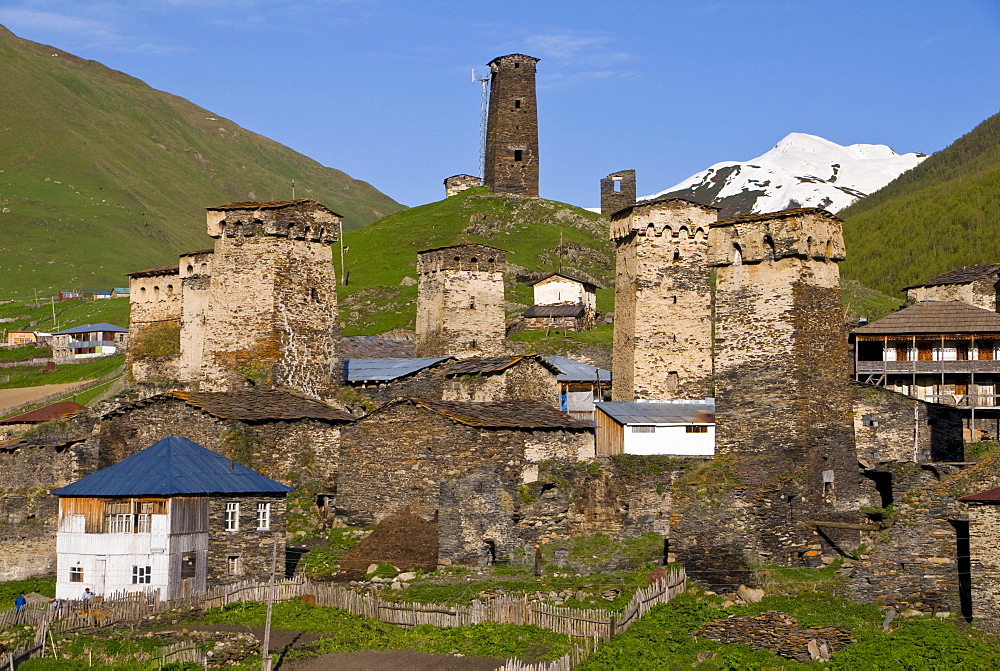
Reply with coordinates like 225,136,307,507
851,302,1000,442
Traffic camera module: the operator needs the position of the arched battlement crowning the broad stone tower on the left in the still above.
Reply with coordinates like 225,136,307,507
206,198,340,244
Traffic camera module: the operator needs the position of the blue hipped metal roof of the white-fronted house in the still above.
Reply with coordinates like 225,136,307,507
52,436,292,496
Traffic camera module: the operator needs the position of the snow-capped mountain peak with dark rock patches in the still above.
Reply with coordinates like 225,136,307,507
640,133,927,217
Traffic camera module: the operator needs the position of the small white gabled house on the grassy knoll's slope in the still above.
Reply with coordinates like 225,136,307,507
522,273,597,331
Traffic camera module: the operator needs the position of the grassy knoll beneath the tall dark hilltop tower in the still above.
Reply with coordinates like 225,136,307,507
340,187,614,335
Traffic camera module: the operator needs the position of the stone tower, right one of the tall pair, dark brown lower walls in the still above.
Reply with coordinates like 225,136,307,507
709,208,858,562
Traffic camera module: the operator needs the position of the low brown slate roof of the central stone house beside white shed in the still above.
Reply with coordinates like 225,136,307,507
396,398,593,430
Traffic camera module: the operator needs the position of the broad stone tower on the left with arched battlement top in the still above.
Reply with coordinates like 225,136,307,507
195,200,342,398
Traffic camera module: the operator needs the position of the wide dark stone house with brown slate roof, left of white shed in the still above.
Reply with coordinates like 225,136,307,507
337,398,594,524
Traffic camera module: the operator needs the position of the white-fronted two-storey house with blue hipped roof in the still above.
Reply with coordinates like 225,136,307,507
52,436,292,599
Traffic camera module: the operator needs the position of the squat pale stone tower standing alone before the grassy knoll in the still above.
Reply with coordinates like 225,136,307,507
416,243,507,357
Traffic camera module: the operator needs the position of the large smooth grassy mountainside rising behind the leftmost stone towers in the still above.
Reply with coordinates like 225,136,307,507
0,27,402,299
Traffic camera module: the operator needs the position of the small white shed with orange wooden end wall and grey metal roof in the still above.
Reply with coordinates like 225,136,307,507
595,398,715,457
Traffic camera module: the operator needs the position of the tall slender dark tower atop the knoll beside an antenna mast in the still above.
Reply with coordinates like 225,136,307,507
483,54,538,197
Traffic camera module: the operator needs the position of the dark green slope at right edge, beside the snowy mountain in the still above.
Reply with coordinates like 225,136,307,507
838,114,1000,295
